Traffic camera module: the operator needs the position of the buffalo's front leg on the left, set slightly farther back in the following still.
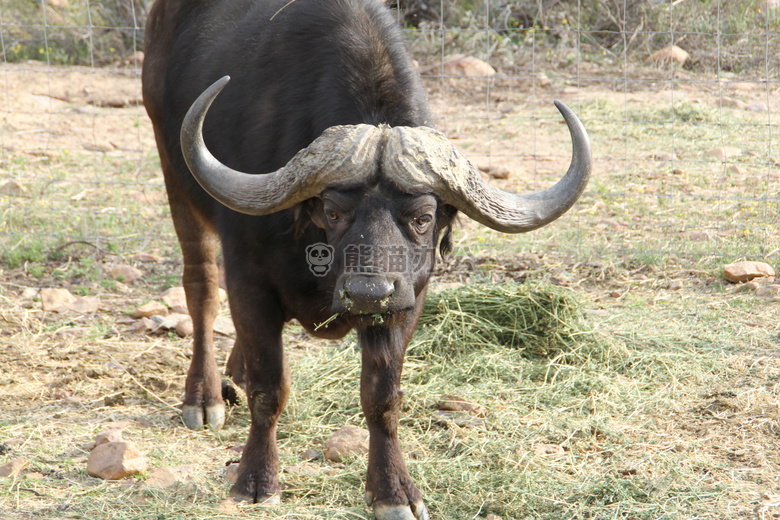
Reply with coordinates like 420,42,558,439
228,284,290,504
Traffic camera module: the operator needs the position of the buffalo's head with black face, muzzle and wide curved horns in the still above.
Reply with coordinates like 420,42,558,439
181,77,591,325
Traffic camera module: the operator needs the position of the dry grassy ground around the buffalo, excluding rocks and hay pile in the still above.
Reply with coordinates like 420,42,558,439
0,52,780,520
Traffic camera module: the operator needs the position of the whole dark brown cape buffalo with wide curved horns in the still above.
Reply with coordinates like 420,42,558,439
143,0,591,520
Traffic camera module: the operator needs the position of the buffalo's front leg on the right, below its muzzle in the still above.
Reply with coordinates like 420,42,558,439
358,327,429,520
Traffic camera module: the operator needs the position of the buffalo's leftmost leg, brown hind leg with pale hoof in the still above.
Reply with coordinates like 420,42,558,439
168,187,225,429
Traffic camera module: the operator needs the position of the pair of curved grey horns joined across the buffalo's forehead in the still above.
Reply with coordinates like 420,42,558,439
181,76,591,233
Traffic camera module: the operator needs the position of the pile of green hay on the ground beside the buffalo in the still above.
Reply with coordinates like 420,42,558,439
409,282,608,363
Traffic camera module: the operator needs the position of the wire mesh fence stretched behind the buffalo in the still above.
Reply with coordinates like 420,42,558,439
0,0,780,272
